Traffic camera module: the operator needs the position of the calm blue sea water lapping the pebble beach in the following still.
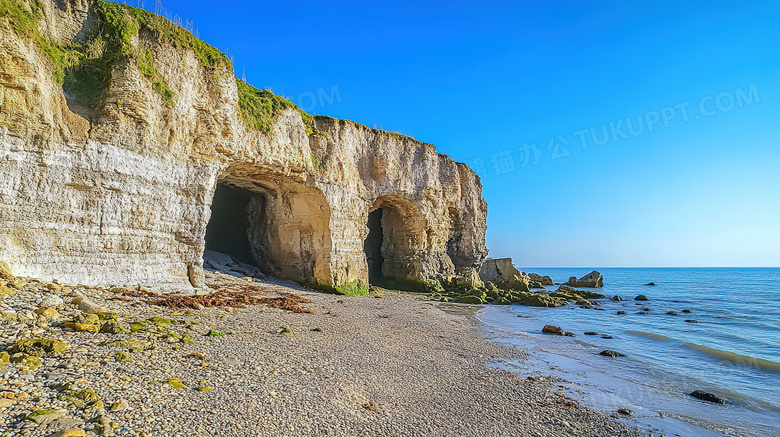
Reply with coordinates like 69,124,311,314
478,268,780,436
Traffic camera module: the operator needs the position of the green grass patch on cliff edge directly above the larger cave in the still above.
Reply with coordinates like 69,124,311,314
236,78,314,135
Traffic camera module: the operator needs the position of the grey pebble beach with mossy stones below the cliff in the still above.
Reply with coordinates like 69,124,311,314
0,273,639,436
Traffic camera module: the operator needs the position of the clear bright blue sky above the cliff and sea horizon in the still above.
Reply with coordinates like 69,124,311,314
148,0,780,267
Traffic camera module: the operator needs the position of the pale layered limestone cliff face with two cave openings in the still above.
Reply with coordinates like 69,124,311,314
0,0,487,289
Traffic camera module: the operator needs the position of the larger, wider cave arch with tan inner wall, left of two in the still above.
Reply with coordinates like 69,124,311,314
205,167,333,287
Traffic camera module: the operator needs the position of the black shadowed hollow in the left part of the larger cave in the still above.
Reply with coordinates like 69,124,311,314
206,184,262,265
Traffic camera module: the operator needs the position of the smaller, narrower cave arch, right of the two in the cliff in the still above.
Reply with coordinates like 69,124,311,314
363,196,426,288
